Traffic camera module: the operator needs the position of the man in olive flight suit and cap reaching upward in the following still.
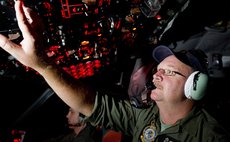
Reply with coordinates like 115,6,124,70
0,1,230,142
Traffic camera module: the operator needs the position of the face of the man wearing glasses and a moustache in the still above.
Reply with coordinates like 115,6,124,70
151,55,192,104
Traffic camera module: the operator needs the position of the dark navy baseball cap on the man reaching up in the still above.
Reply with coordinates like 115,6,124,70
152,45,208,73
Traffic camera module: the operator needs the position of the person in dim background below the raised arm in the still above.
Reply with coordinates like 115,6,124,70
43,108,102,142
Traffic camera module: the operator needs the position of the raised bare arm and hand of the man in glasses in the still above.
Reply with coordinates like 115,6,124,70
0,1,95,116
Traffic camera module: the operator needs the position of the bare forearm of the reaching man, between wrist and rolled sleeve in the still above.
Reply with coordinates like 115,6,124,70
40,65,95,116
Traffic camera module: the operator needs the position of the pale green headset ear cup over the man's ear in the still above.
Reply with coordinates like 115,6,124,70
184,71,208,100
